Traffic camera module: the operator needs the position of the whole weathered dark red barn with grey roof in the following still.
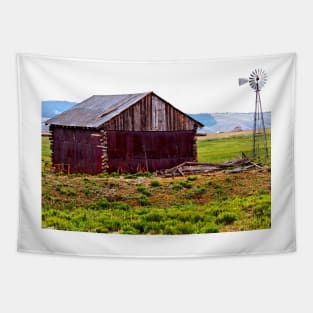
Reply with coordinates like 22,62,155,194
46,92,203,174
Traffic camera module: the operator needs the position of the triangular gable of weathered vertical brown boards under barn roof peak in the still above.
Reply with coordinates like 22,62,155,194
104,94,195,131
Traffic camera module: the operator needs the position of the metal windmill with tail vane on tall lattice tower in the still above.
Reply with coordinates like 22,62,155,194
239,69,268,159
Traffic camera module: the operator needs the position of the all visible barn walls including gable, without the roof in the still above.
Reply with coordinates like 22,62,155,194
51,94,197,174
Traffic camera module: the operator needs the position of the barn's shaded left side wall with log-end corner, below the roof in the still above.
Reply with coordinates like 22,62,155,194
51,127,102,174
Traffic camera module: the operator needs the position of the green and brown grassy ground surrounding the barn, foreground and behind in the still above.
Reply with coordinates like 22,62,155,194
42,134,271,234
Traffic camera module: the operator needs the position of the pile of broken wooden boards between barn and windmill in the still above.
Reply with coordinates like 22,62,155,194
158,157,263,177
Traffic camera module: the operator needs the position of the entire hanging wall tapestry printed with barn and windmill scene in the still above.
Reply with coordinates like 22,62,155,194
17,53,296,258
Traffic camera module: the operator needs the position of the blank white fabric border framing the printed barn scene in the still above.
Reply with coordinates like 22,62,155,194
17,53,296,258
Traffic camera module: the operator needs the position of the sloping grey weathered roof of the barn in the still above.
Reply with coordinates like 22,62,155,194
46,92,203,128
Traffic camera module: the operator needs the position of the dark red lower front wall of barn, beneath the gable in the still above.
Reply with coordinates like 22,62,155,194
107,131,196,172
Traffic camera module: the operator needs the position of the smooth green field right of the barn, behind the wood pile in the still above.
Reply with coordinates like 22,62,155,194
197,133,271,163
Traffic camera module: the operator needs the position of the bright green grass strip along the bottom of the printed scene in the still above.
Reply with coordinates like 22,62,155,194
42,195,271,234
